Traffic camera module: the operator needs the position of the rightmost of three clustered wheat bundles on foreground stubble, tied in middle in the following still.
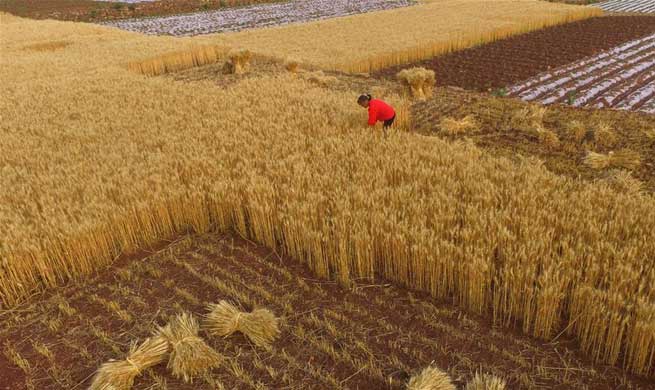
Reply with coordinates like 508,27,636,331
205,301,280,347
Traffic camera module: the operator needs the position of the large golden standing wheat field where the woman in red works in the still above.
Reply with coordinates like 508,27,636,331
0,6,655,375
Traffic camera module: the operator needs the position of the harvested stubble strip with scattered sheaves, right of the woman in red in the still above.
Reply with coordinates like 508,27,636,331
412,87,655,192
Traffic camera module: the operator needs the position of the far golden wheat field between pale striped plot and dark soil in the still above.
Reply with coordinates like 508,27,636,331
209,0,602,72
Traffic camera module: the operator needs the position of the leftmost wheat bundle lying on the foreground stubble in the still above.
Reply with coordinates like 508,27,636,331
89,337,169,390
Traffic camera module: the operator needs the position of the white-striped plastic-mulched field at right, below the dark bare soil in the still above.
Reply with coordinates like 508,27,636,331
509,34,655,113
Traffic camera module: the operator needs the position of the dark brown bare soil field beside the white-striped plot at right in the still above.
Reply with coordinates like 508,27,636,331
376,16,655,91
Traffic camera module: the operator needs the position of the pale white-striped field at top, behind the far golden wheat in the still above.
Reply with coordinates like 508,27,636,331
107,0,413,36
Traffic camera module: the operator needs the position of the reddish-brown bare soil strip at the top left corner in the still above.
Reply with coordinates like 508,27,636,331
0,0,278,22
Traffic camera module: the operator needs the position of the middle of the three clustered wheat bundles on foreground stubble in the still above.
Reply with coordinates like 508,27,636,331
158,313,222,383
